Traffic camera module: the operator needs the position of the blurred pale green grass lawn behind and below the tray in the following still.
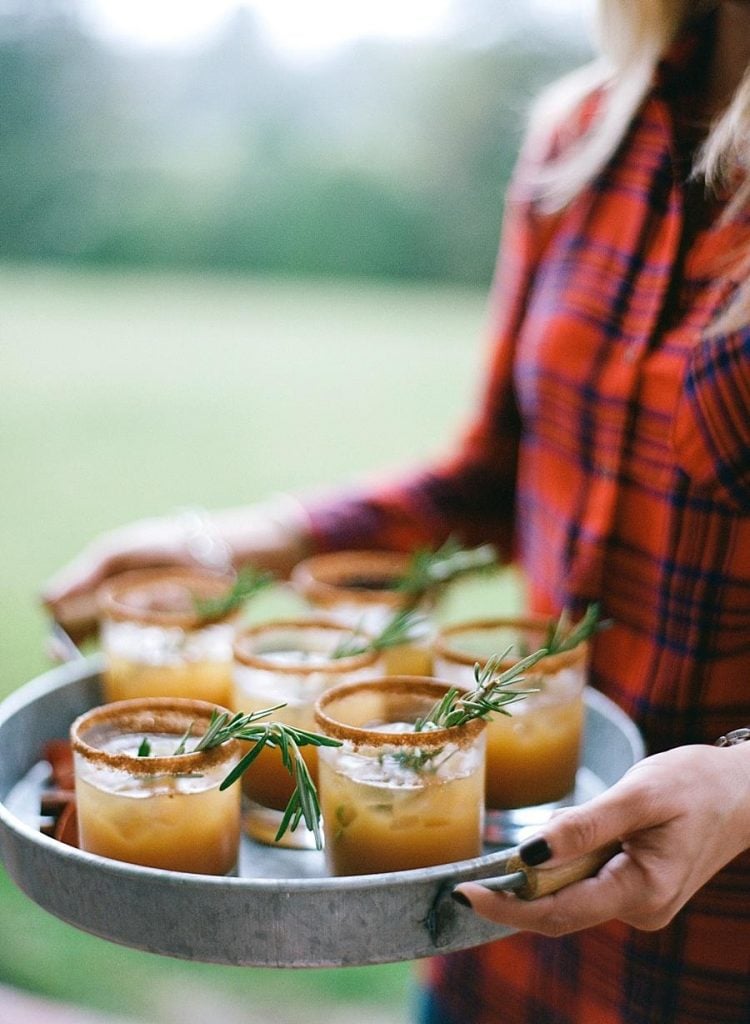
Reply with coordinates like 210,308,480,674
0,266,514,1024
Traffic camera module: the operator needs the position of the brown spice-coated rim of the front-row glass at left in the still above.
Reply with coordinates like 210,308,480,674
70,697,243,776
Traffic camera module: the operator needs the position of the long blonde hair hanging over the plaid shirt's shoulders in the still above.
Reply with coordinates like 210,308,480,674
529,0,750,330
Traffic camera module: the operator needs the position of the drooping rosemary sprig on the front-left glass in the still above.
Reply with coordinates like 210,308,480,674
138,703,341,850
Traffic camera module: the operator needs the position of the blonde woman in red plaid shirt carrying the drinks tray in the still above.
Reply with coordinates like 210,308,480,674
46,0,750,1024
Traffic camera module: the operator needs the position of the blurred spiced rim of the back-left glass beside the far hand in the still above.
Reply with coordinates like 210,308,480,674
95,565,237,629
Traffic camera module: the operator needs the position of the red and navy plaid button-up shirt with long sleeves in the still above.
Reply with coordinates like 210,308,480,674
311,22,750,1024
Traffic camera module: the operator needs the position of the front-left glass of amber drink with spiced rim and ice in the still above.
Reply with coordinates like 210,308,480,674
71,698,242,874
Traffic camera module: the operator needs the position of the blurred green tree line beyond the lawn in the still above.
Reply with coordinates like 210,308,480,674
0,0,588,286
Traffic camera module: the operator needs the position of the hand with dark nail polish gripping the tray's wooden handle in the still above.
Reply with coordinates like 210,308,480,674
454,742,750,936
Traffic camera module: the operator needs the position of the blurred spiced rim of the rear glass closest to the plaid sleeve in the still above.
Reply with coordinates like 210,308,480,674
289,549,411,608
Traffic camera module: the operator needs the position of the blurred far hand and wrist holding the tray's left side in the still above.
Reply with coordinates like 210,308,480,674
41,498,310,643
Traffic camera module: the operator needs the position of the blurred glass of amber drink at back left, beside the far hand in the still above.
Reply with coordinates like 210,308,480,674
97,568,237,706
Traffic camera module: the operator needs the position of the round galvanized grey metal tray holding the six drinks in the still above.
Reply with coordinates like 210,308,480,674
0,656,643,968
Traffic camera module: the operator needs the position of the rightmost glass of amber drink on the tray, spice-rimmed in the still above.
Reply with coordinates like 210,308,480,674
434,617,588,845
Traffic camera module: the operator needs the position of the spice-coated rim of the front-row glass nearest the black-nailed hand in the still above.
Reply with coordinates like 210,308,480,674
315,676,487,748
